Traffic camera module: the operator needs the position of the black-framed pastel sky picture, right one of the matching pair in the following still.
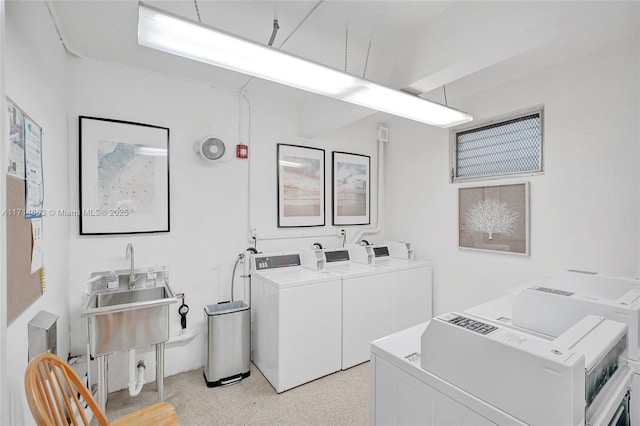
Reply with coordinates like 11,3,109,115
331,151,371,226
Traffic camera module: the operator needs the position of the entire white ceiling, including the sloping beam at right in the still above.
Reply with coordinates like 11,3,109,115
48,0,640,131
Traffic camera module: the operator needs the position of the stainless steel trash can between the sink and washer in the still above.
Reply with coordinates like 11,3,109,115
204,300,251,388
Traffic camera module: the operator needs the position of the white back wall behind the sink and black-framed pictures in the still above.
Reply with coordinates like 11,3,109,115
67,58,377,390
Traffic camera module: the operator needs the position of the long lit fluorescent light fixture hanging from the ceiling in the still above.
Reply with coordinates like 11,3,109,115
138,2,473,127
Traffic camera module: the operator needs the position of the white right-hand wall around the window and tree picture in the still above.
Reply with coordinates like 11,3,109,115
386,35,640,313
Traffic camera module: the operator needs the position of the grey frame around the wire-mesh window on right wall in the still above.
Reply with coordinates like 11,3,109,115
449,104,545,183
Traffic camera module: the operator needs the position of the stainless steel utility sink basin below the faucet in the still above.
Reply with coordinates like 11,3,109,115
81,268,176,356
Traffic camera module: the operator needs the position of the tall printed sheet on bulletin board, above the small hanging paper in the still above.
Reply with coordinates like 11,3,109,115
24,117,44,219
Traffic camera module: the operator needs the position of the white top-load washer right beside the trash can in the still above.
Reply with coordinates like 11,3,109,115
251,253,342,393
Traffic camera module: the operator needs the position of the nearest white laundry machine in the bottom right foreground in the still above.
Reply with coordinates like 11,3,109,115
371,312,632,426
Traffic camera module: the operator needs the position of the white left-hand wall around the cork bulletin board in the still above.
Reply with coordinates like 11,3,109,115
2,1,69,425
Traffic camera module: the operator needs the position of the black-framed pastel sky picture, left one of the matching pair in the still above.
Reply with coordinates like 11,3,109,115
277,144,326,228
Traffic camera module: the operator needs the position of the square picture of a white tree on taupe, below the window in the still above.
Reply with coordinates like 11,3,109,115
458,182,529,256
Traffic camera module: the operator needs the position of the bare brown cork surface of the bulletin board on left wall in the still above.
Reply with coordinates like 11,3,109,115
5,176,42,322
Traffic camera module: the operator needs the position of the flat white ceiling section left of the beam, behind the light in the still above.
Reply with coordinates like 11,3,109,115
51,0,454,88
